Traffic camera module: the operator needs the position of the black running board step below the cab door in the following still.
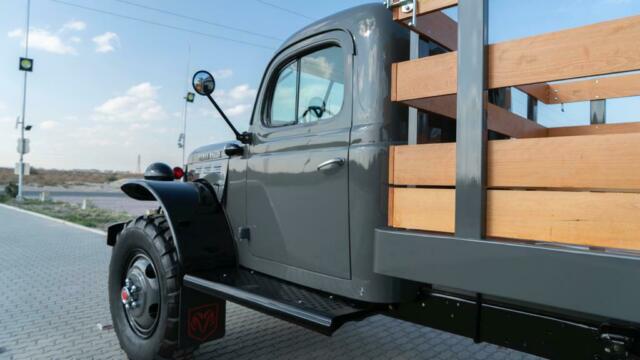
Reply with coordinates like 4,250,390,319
183,268,376,335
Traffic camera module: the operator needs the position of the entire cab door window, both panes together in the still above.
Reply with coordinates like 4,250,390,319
266,46,344,126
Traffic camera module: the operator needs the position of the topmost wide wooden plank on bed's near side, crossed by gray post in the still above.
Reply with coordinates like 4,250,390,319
396,16,640,101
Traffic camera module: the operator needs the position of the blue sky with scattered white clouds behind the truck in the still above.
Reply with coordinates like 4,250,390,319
0,0,640,171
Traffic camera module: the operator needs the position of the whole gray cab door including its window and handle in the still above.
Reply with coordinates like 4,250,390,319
247,31,353,279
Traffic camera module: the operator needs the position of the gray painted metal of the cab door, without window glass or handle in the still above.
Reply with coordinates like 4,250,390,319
247,30,353,279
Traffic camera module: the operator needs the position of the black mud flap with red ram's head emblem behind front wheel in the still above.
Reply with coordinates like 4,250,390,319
179,287,227,348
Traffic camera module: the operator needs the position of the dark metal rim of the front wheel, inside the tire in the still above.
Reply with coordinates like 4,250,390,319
120,253,161,338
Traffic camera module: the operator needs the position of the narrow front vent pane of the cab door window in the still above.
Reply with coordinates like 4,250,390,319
269,61,298,126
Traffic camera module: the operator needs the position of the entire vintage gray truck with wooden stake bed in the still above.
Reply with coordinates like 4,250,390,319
107,0,640,359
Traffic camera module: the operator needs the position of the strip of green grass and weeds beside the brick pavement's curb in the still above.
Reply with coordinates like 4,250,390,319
0,199,131,230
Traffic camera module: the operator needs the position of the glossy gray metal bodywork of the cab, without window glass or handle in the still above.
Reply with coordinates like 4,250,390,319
189,5,415,302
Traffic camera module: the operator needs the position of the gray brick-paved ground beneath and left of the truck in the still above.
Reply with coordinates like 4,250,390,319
0,207,533,360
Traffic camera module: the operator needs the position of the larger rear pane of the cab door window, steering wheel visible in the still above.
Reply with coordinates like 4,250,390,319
297,46,344,123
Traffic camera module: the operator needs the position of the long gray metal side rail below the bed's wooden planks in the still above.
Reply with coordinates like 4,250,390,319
374,229,640,323
